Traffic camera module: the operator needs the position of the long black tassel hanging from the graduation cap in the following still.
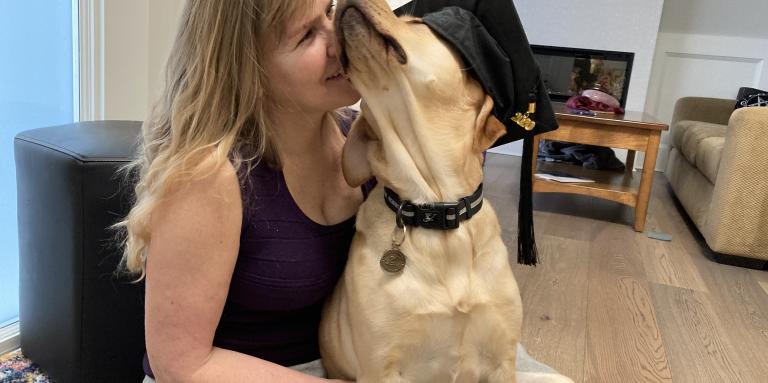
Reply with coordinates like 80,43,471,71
517,135,538,266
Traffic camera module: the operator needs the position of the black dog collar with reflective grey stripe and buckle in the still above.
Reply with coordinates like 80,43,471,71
384,184,483,230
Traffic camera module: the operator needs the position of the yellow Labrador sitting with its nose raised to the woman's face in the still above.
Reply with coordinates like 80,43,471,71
320,0,570,383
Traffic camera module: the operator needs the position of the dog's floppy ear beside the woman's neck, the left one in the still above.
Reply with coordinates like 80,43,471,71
341,115,373,187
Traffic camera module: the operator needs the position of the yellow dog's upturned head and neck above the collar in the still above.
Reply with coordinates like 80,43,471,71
335,0,505,202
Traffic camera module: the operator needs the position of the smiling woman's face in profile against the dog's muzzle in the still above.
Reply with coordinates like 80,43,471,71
265,0,360,113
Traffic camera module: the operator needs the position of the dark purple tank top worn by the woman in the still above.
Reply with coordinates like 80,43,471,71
144,112,375,376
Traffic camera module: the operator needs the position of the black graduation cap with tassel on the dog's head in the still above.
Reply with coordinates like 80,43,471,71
395,0,557,265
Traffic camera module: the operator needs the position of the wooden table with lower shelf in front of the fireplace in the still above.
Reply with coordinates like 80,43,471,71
533,103,668,231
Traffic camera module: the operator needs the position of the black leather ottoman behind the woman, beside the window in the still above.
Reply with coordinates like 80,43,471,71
14,121,144,383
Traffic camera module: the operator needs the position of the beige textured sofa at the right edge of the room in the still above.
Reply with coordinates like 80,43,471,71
666,97,768,266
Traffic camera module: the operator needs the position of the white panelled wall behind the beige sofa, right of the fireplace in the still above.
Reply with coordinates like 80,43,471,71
646,0,768,170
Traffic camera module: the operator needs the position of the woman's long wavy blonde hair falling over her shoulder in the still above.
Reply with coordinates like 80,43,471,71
114,0,313,280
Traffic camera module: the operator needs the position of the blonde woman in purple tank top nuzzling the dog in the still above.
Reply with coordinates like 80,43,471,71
118,0,371,383
